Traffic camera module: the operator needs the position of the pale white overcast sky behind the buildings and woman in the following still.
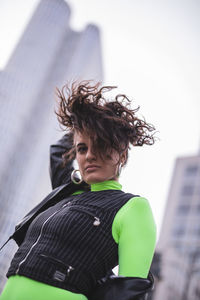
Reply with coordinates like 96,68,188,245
0,0,200,240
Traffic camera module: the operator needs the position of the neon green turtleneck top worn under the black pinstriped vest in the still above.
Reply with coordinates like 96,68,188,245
0,180,156,300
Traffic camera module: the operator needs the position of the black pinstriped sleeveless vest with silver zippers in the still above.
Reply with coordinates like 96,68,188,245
6,190,138,296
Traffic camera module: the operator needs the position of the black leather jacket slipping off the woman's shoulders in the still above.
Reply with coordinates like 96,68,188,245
0,134,154,300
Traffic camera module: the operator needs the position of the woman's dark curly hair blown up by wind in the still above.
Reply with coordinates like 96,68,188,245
55,81,158,165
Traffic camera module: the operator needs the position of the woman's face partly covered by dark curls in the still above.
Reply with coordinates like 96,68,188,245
74,132,123,184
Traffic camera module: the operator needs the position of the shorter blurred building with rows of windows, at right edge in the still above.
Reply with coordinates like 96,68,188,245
153,154,200,300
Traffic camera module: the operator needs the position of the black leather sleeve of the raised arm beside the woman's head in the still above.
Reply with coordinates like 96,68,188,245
49,134,74,189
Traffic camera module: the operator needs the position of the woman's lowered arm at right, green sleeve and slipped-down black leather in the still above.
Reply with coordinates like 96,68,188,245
88,197,156,300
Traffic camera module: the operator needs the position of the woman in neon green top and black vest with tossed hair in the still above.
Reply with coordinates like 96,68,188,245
0,82,159,300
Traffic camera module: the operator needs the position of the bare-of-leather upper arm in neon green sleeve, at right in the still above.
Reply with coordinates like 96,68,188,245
112,197,156,278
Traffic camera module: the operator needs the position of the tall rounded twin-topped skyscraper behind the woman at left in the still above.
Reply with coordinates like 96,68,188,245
0,0,103,290
